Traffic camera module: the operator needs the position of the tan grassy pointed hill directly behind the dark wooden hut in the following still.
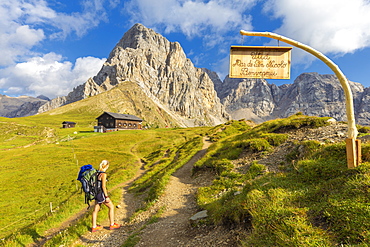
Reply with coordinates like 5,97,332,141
42,81,185,127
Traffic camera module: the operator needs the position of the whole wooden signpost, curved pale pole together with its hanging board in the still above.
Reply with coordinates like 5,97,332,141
234,30,361,168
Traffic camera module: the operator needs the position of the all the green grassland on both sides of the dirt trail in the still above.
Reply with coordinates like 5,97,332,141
0,99,370,247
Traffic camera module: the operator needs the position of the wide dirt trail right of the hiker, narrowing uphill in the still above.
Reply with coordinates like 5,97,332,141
136,139,240,247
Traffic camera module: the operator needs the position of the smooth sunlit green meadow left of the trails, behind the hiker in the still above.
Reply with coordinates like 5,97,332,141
0,117,207,247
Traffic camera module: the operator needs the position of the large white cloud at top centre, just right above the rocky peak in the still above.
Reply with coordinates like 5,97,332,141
125,0,258,40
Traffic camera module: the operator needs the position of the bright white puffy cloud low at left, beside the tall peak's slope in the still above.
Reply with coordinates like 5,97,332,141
0,53,105,98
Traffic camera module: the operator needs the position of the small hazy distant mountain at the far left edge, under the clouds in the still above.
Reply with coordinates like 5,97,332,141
0,94,49,118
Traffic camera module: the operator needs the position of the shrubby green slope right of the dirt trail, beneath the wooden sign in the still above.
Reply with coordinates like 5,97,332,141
195,115,370,246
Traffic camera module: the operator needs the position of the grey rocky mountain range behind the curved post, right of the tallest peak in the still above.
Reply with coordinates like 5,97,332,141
215,73,370,125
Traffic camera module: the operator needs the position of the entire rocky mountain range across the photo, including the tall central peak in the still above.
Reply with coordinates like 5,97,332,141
0,24,370,127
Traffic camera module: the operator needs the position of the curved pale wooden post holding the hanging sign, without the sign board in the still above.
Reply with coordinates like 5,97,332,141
240,30,361,168
